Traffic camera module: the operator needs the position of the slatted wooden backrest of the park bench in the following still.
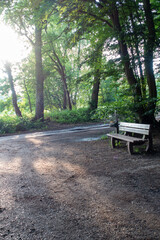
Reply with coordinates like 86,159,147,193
119,122,150,135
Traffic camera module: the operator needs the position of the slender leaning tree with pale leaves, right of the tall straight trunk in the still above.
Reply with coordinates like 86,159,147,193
43,14,72,110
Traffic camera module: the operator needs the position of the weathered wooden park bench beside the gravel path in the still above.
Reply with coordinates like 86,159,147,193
107,122,152,154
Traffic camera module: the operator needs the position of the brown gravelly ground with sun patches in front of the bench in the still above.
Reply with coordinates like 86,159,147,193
0,124,160,240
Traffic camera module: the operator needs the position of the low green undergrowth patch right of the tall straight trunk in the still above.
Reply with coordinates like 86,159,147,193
47,108,91,123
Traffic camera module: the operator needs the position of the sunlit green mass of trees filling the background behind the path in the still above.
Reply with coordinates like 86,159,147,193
1,0,160,124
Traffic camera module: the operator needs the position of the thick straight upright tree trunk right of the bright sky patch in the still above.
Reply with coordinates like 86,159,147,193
35,27,44,121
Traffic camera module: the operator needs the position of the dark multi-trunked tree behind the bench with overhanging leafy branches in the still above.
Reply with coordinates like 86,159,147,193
55,0,157,123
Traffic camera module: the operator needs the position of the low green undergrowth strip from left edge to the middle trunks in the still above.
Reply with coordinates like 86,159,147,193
0,109,98,134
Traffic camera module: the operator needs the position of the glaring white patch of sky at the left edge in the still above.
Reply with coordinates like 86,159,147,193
0,24,28,65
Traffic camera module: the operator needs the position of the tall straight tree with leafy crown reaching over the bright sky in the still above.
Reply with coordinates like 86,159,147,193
5,0,45,120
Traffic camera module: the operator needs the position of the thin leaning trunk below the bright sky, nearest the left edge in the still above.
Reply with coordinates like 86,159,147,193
5,63,22,117
